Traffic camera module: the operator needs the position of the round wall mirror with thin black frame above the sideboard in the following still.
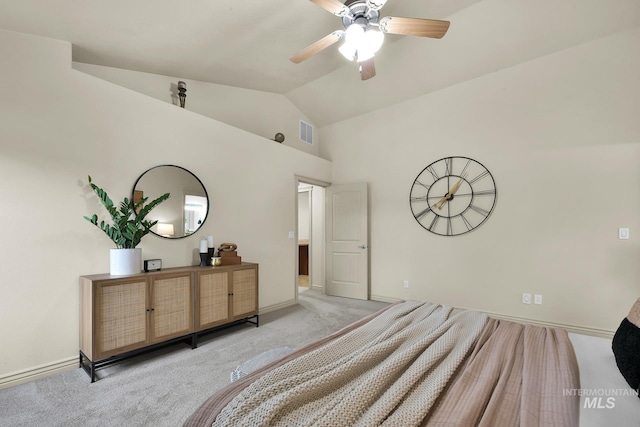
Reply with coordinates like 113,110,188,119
131,165,209,239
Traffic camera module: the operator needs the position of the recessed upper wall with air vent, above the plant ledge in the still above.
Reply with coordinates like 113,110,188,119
73,62,320,155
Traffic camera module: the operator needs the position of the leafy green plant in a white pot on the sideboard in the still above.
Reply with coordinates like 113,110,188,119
84,176,169,276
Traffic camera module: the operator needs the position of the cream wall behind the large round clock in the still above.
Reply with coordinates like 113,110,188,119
321,27,640,334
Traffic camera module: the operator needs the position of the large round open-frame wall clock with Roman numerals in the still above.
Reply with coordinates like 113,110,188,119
409,156,497,236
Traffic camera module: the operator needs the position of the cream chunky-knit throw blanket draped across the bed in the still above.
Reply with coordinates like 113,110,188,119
213,301,487,427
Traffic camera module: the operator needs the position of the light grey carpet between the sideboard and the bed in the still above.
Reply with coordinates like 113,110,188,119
0,290,387,427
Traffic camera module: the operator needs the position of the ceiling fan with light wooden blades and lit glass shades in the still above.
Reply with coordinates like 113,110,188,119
289,0,449,80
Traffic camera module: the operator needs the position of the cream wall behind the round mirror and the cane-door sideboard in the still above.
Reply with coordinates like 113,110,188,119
0,30,331,385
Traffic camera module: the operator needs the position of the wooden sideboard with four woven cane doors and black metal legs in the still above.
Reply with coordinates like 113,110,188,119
80,262,259,382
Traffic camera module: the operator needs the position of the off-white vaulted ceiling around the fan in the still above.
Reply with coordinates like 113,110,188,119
0,0,640,126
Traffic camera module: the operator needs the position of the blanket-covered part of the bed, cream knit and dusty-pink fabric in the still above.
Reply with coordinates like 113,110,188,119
185,301,580,427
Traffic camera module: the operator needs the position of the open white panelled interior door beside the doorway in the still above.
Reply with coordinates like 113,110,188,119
325,183,369,300
